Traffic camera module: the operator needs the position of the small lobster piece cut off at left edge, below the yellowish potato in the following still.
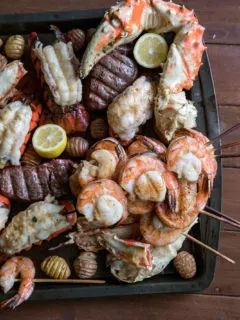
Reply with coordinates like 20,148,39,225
0,60,27,102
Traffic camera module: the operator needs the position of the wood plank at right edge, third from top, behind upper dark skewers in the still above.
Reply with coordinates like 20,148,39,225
219,106,240,168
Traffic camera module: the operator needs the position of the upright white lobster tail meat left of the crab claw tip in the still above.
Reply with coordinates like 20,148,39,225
29,32,82,109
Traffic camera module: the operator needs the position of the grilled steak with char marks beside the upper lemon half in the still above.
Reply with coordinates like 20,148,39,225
84,49,138,110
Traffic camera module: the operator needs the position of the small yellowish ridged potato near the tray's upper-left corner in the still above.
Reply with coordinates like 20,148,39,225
4,35,25,60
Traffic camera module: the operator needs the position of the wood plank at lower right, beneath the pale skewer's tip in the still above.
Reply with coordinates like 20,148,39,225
204,231,240,296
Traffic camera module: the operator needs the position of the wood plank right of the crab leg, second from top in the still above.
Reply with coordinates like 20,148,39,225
208,44,240,106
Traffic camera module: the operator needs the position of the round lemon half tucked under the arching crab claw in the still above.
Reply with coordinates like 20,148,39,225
133,33,168,69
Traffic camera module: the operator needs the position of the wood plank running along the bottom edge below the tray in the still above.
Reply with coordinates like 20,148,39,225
1,294,240,320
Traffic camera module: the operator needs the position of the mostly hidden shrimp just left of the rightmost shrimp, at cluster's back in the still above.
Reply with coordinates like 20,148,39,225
127,135,167,161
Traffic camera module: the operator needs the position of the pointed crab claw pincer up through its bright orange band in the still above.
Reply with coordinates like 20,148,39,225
80,0,149,78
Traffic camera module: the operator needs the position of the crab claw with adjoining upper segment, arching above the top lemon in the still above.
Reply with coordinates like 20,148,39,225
80,0,198,78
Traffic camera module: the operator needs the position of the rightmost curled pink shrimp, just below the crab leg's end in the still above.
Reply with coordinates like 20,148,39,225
167,129,217,189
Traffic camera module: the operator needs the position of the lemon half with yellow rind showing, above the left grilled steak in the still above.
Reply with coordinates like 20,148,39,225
32,124,67,159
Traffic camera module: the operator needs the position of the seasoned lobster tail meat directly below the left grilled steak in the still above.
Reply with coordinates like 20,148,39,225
0,196,76,255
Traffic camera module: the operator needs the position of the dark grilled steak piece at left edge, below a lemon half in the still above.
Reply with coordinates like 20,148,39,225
0,159,73,202
